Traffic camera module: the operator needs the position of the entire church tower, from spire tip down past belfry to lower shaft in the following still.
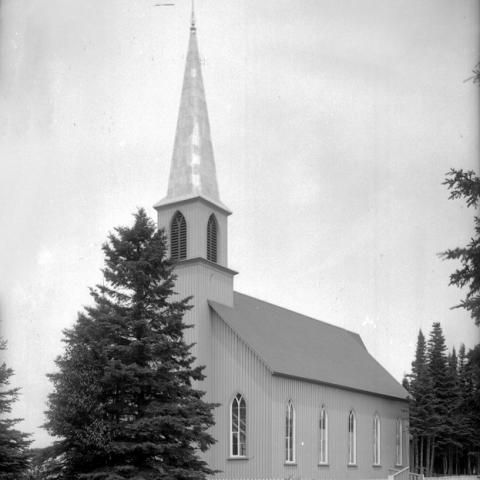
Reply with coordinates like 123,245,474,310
154,7,236,376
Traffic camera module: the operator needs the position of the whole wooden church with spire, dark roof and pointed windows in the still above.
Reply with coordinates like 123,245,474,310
154,8,409,480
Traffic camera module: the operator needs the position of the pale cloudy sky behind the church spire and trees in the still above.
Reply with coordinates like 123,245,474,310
0,0,479,446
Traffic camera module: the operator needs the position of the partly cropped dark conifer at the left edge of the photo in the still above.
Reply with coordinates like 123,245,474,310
0,339,30,480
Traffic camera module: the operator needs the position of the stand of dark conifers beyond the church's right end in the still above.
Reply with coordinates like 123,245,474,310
407,323,480,476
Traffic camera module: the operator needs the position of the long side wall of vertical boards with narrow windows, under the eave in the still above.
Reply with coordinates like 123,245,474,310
272,377,407,479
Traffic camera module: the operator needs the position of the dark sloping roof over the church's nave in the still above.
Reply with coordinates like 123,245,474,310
208,292,408,399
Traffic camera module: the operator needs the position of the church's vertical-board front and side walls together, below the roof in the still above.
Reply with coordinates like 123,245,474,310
208,312,408,480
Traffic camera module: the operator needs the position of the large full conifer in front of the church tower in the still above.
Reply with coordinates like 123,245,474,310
46,210,215,480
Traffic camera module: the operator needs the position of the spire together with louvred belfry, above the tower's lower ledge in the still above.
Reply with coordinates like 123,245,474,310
154,6,233,270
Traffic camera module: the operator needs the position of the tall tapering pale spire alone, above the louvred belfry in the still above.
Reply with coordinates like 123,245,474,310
165,5,220,203
